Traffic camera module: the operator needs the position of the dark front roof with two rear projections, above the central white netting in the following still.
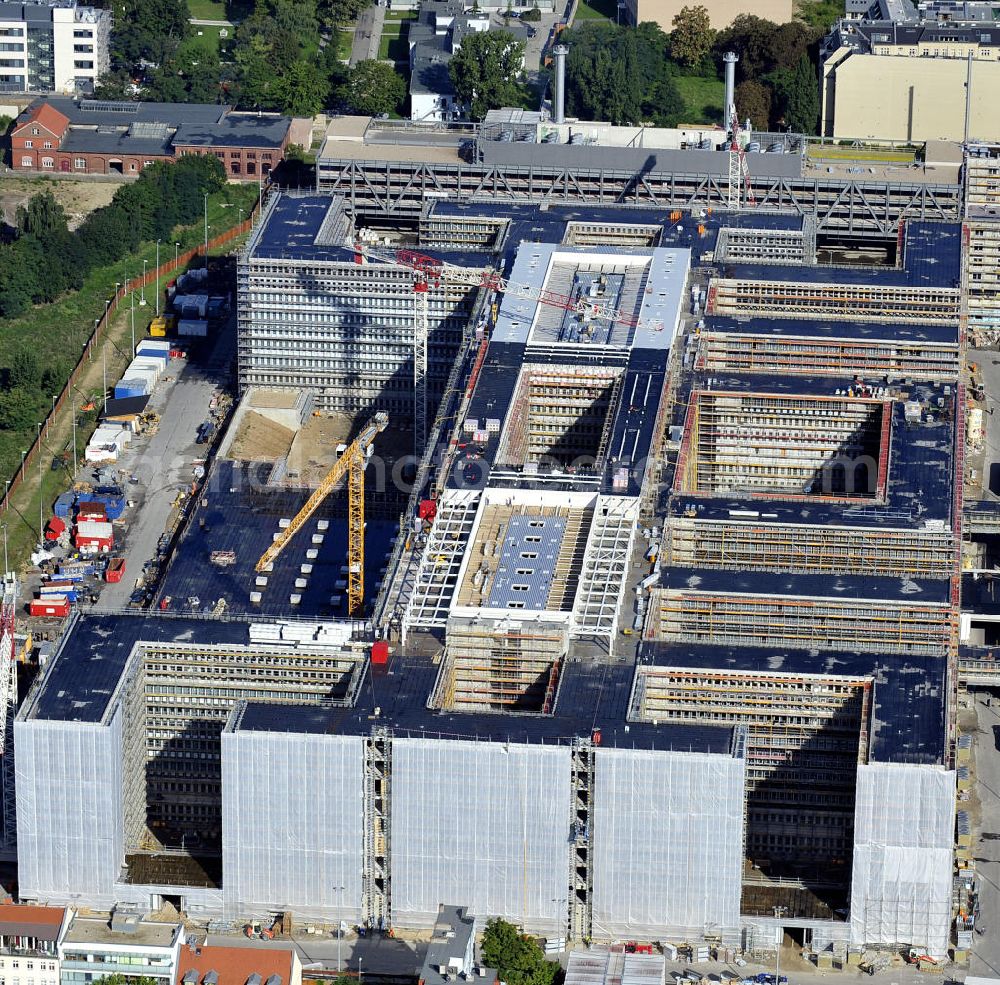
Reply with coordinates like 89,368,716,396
227,654,733,755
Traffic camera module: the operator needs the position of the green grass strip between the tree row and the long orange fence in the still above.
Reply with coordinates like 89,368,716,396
0,185,257,566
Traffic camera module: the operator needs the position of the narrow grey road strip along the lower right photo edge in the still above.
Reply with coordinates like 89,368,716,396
969,693,1000,978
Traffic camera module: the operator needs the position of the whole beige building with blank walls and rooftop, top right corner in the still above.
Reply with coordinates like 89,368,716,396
820,23,1000,143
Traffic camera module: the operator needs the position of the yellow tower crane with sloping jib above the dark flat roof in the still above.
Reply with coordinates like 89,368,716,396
257,413,389,616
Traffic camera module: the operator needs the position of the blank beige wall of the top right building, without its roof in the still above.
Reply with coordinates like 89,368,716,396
821,52,1000,143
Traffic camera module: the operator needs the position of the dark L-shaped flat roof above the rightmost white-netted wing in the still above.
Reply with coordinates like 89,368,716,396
639,642,947,764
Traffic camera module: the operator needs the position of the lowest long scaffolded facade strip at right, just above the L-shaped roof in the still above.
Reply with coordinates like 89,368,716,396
647,589,956,655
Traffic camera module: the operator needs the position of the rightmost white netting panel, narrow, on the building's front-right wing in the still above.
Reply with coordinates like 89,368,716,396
851,763,955,957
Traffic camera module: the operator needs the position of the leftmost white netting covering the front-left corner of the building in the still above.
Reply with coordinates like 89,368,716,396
14,711,124,908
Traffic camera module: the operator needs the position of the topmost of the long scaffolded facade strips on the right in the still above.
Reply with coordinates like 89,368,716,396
705,278,961,324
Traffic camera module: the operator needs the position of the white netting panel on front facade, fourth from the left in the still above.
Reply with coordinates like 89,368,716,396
591,749,744,938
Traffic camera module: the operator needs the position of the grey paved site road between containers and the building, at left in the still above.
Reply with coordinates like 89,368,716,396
96,320,236,609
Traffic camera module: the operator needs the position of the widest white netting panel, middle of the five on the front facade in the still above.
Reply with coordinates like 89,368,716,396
392,738,570,934
